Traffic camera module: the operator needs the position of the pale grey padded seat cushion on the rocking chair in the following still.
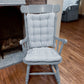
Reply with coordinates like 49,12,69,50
24,47,62,62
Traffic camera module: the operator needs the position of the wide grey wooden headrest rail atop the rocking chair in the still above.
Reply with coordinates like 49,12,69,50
21,5,60,13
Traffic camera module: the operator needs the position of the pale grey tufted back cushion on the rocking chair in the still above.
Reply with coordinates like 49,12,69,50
27,13,55,48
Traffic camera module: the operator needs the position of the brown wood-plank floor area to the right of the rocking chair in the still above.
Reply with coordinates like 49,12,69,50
59,18,84,84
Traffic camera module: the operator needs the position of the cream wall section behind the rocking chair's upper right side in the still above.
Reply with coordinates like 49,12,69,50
47,0,63,37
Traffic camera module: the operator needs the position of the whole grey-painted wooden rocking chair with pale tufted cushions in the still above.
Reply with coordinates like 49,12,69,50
20,5,67,84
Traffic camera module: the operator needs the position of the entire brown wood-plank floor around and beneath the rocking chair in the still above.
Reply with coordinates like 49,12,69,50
0,18,84,84
